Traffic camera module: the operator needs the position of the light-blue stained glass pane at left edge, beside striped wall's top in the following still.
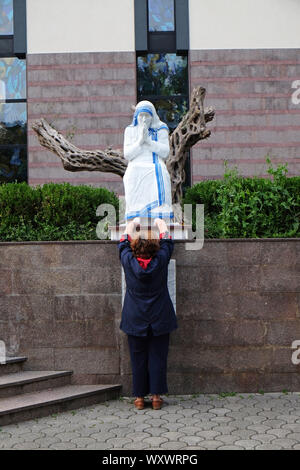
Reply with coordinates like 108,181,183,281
0,57,26,100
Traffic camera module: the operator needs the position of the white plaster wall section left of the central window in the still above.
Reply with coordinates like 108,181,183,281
27,0,134,54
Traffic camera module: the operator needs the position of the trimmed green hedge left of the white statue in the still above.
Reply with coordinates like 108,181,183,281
0,182,119,241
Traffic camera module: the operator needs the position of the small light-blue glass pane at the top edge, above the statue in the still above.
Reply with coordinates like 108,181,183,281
148,0,175,32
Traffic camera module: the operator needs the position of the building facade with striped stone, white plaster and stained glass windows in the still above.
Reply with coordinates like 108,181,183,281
0,0,300,194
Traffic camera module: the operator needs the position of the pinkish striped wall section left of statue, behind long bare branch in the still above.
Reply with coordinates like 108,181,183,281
27,52,136,194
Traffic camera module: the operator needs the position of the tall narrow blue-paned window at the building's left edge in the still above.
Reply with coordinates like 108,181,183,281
0,0,27,183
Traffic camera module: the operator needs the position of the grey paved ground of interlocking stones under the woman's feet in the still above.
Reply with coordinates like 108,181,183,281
0,392,300,450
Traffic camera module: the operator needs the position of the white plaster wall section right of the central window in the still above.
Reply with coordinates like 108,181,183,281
189,0,300,50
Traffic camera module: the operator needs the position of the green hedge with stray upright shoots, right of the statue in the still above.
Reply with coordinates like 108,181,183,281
182,157,300,238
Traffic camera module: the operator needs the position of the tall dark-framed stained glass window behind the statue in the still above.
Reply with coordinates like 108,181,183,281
135,0,190,187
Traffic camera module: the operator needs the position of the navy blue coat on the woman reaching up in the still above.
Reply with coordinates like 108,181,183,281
118,238,177,336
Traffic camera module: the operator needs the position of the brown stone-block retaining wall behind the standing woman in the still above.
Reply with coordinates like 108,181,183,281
0,239,300,395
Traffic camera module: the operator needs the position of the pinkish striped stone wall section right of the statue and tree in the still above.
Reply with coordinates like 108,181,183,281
190,49,300,183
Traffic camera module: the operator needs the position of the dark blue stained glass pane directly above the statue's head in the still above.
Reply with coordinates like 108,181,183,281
137,54,188,95
